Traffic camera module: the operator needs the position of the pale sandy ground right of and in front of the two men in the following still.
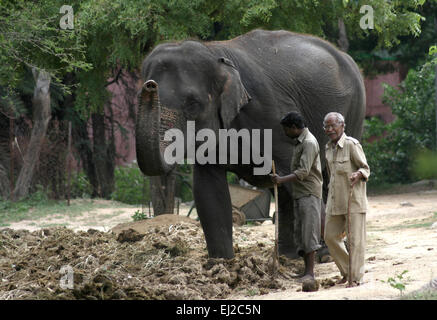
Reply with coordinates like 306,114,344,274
231,190,437,300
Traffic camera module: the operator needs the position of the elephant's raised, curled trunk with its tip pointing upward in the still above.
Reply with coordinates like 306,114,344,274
135,80,180,176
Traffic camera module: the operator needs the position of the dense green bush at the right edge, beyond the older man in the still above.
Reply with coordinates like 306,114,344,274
363,58,436,186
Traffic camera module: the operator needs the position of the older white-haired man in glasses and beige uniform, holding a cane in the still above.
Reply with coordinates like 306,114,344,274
323,112,370,285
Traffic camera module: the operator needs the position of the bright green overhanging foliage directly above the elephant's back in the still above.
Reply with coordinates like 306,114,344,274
211,0,425,47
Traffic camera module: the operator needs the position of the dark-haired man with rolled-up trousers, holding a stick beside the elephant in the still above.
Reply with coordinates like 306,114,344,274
271,112,323,280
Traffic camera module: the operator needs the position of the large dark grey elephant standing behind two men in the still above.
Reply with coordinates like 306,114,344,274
135,30,365,259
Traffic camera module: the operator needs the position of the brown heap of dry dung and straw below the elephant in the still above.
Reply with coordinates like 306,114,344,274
0,217,303,299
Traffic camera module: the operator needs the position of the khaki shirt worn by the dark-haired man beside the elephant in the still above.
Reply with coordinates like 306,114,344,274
291,128,323,199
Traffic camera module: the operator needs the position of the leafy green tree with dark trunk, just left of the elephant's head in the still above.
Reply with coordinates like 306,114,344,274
70,0,218,198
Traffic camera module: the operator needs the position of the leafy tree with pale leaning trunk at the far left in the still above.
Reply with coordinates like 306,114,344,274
0,0,90,199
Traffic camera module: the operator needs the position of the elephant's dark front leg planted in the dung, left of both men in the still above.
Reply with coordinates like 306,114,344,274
193,165,234,259
